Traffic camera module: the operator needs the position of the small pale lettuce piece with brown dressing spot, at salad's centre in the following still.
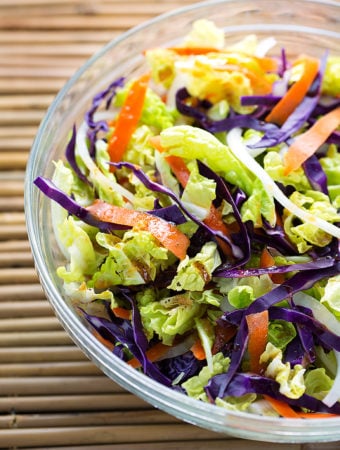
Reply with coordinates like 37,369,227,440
168,242,221,291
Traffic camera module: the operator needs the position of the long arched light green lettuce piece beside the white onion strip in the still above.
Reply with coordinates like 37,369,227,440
160,125,276,225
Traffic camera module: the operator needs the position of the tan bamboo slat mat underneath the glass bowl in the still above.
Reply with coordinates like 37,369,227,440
0,0,340,450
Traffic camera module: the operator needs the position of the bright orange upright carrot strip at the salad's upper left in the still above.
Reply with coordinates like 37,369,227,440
108,74,150,162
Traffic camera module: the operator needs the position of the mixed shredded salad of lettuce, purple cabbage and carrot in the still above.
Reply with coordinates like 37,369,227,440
35,20,340,418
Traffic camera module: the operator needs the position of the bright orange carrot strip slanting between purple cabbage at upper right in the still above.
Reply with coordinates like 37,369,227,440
265,57,319,125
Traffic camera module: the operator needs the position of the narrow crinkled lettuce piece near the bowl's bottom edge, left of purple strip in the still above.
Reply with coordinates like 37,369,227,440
182,352,230,401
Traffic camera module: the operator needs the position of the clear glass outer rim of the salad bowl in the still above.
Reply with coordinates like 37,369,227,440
25,0,340,443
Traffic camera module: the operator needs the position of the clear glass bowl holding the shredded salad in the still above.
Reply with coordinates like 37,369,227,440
25,0,340,443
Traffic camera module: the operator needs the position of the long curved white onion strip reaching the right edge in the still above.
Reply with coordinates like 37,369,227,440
227,128,340,239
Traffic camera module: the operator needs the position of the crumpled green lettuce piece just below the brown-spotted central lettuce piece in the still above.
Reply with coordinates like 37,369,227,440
140,295,206,345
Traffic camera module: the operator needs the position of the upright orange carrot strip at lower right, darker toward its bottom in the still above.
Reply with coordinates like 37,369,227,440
246,310,269,373
